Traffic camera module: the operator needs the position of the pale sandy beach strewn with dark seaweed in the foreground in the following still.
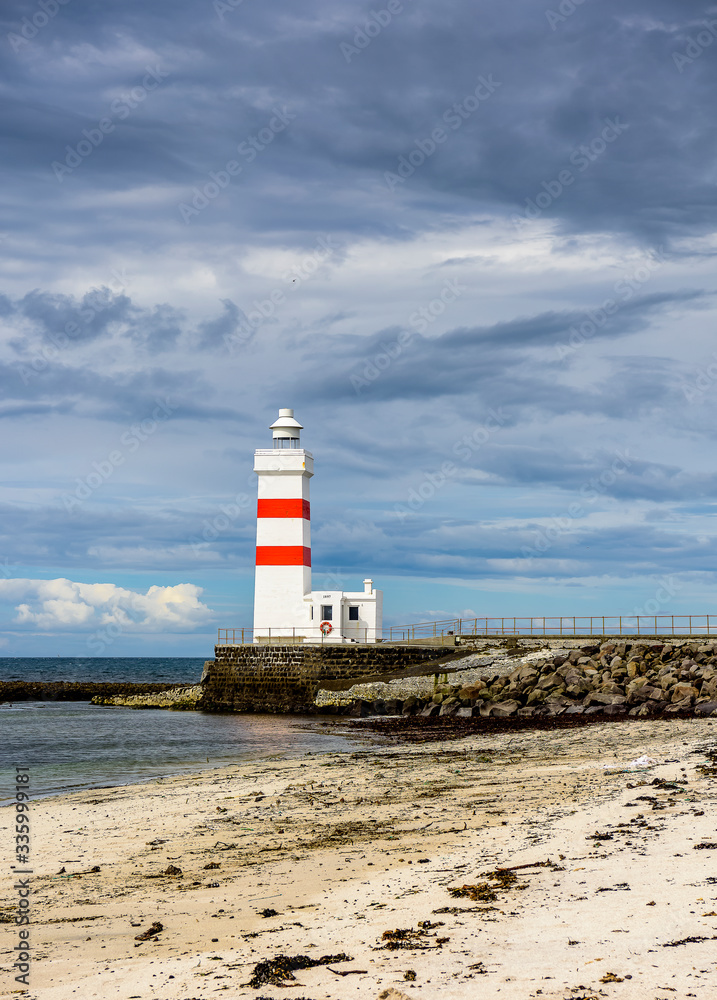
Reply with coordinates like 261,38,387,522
5,718,717,1000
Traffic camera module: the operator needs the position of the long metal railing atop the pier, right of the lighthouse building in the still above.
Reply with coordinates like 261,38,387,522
384,615,717,642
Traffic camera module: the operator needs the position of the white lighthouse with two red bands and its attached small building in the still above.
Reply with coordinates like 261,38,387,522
254,409,383,642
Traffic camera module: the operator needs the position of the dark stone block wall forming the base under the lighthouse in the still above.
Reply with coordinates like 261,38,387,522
201,644,465,712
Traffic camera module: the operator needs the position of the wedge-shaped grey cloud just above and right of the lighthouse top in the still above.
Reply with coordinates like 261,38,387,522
304,291,707,416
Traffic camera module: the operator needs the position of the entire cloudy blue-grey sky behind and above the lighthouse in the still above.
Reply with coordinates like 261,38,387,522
0,0,717,657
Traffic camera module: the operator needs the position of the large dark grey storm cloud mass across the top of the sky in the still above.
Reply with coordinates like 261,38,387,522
0,0,717,242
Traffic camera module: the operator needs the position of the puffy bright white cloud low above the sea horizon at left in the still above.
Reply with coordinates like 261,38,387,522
0,578,214,632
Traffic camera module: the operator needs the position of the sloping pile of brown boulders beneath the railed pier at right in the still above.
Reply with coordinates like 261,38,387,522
334,640,717,718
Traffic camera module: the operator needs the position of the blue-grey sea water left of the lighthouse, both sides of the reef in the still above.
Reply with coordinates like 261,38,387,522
0,657,365,804
